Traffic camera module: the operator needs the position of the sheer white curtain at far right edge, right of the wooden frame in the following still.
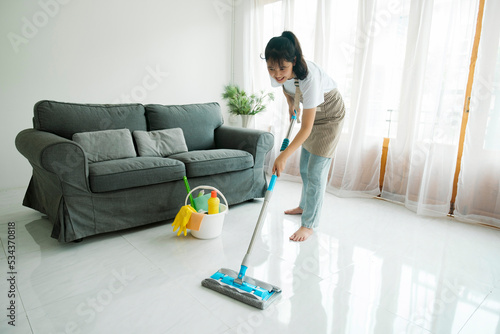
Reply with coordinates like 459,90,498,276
455,0,500,227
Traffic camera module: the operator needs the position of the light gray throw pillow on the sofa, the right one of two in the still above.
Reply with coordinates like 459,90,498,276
134,128,187,157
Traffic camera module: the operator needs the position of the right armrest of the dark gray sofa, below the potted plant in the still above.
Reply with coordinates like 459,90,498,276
215,125,274,163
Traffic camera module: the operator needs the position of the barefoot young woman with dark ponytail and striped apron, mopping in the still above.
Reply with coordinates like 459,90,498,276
265,31,345,241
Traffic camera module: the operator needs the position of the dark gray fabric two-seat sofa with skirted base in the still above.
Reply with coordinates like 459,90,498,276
16,100,274,242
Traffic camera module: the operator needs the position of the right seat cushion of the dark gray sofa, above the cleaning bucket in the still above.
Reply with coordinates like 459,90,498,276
169,149,254,178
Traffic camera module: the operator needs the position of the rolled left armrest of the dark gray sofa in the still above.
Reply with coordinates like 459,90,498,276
15,129,89,188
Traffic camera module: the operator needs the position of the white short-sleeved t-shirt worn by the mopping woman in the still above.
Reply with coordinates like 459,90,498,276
271,60,337,109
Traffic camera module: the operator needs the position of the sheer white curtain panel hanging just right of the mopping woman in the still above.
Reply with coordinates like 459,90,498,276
328,0,404,196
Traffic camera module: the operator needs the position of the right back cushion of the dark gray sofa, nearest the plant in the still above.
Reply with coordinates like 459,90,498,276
146,102,224,151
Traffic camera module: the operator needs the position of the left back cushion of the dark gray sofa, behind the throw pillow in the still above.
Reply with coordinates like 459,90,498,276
33,100,146,139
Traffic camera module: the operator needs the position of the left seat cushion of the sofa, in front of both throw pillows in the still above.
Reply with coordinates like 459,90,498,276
89,157,185,193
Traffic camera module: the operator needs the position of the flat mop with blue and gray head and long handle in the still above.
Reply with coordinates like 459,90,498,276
201,112,297,310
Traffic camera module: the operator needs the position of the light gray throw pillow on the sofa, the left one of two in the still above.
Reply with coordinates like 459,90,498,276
73,129,136,162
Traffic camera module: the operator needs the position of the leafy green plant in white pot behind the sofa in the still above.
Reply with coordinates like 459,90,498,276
222,84,274,128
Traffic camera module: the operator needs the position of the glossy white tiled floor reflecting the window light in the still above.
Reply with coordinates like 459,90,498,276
0,181,500,334
